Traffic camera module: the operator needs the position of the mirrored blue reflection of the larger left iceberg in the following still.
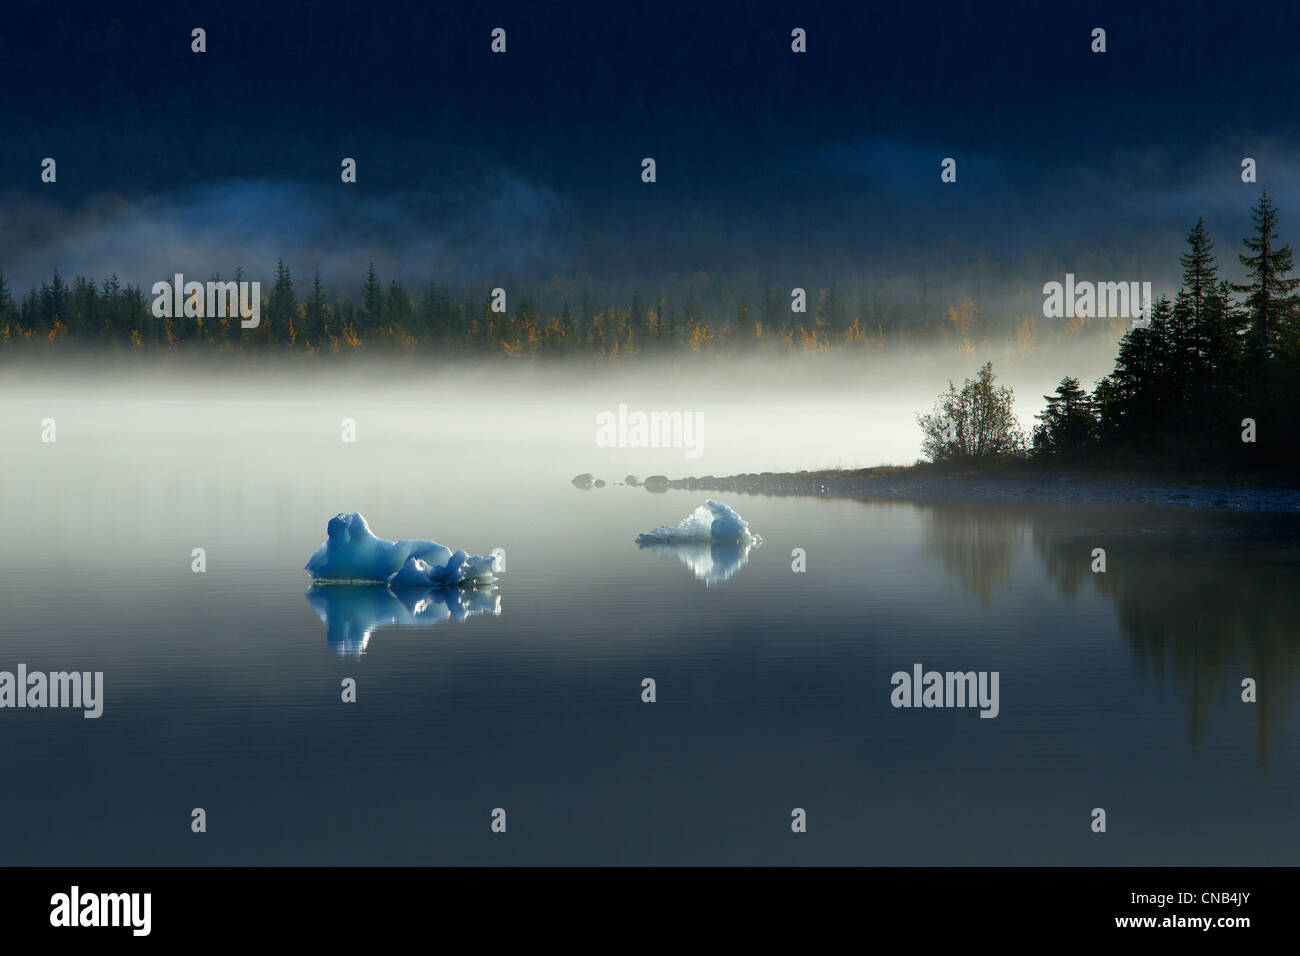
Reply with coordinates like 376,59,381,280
306,584,501,656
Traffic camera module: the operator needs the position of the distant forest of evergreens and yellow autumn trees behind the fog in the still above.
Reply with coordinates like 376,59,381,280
0,261,1118,358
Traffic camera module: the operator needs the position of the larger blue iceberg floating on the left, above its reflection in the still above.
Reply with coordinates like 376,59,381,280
306,511,495,588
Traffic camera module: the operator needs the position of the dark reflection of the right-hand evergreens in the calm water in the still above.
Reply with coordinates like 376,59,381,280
924,502,1300,766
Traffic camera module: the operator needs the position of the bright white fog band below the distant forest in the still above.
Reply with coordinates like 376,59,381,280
0,341,1114,488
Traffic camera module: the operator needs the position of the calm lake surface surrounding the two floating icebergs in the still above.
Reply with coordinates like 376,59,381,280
0,382,1300,865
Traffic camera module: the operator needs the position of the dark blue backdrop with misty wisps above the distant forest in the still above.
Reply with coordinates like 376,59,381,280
0,0,1300,295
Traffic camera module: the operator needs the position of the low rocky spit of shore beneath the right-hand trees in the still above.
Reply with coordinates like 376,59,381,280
595,466,1300,514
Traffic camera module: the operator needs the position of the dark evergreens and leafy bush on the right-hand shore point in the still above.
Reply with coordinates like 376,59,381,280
918,193,1300,471
